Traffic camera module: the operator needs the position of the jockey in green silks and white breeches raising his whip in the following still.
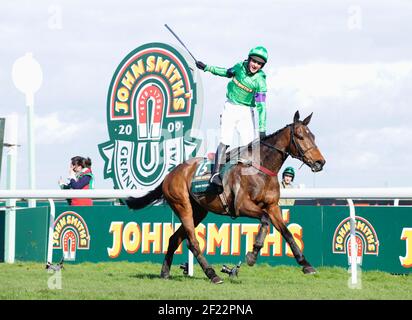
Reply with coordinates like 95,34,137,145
196,46,268,188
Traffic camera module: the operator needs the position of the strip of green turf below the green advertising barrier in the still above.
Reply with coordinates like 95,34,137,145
0,262,412,300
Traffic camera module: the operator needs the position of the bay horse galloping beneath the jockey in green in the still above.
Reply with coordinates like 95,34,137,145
126,111,326,283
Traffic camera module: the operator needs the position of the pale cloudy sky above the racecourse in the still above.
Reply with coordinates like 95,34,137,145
0,0,412,189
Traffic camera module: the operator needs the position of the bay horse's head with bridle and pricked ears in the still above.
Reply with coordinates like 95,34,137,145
287,111,326,172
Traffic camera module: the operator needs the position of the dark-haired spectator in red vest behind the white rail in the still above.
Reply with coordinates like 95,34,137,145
59,156,94,206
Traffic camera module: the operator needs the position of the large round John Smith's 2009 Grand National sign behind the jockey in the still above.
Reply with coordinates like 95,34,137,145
99,43,201,192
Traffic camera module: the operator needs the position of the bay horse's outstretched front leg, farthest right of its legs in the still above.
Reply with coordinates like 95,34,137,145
268,205,316,274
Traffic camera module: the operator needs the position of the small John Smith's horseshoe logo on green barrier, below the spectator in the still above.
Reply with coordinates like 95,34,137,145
53,211,90,261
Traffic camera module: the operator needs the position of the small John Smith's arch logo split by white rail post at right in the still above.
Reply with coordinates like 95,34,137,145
332,217,379,264
